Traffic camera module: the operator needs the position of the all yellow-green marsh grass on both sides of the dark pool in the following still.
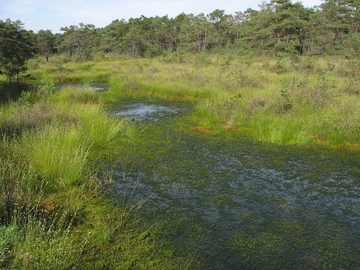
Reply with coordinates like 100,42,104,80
0,54,360,269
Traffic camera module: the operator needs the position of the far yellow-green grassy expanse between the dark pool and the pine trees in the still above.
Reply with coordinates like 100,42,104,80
23,54,360,149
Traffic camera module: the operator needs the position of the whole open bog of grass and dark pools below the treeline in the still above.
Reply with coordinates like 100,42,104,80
0,53,360,269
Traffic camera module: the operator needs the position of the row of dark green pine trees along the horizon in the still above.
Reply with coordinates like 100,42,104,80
0,0,360,77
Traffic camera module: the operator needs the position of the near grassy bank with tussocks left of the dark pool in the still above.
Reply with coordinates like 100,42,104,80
0,84,191,269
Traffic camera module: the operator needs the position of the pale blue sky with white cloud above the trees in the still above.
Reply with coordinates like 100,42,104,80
0,0,322,33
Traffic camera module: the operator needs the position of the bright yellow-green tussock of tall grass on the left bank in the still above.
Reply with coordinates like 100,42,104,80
18,127,89,191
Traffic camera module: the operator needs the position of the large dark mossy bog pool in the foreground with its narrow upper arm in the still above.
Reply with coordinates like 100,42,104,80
111,101,360,269
